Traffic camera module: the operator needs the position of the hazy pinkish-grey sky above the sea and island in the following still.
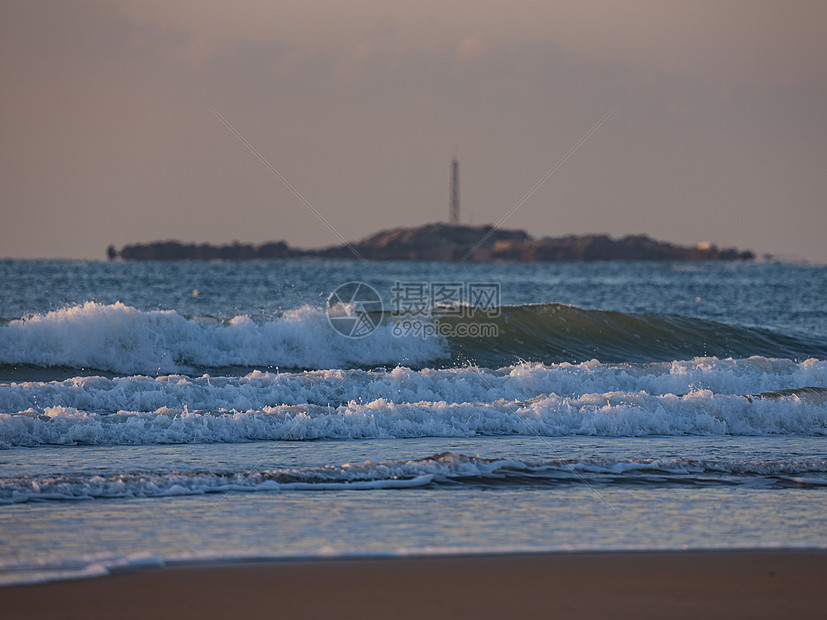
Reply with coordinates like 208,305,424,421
0,0,827,263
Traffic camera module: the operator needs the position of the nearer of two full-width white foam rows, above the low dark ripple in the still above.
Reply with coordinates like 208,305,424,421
0,388,827,447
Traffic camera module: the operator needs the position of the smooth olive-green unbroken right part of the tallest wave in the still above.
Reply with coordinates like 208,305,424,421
438,304,827,367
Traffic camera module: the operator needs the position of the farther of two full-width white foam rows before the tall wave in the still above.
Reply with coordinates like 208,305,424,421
0,357,827,413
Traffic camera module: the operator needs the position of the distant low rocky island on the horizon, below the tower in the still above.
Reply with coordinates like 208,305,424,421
107,223,755,263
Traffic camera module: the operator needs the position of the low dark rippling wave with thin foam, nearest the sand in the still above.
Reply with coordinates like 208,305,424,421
0,452,827,504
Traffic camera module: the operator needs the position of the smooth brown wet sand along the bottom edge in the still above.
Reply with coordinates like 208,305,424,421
0,551,827,619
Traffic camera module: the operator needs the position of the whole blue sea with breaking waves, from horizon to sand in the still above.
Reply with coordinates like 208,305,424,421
0,259,827,585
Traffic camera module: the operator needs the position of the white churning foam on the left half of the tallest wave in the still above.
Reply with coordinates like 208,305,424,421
0,301,447,374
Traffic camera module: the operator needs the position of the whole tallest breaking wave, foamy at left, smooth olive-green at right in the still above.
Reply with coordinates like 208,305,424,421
0,302,827,375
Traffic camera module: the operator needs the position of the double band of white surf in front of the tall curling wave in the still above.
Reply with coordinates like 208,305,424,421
0,357,827,448
